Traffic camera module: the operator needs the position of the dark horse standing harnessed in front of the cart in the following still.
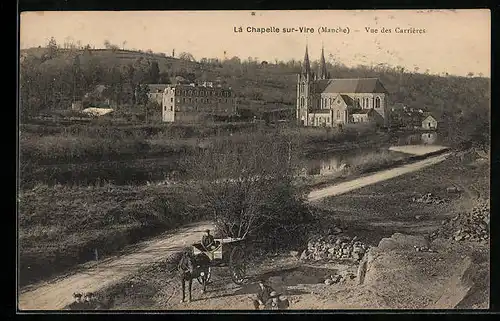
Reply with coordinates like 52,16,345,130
177,251,210,303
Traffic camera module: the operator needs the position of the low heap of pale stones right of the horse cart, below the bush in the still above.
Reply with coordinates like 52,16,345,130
300,235,368,261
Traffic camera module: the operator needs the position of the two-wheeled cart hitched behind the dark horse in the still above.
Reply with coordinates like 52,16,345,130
193,238,247,285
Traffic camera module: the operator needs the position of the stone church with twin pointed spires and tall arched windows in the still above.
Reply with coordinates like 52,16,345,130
296,46,389,127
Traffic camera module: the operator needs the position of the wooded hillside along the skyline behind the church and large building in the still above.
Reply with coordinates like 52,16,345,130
20,39,490,147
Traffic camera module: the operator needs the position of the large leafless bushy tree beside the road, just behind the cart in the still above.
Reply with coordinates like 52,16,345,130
186,132,306,242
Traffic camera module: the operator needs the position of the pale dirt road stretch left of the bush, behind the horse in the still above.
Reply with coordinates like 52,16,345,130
18,222,213,310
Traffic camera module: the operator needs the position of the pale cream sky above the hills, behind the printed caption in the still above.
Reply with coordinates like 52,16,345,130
19,9,491,77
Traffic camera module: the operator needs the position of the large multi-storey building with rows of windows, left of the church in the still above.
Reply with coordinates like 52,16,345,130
162,82,237,122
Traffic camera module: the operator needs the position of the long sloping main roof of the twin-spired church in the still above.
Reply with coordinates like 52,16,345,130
316,78,387,93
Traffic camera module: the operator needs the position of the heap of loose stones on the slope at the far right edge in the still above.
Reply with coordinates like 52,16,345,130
431,201,490,242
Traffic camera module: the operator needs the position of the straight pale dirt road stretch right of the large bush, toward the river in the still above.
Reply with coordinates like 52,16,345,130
308,153,450,202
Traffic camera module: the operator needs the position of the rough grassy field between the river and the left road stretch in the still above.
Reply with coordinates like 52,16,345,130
18,184,203,285
